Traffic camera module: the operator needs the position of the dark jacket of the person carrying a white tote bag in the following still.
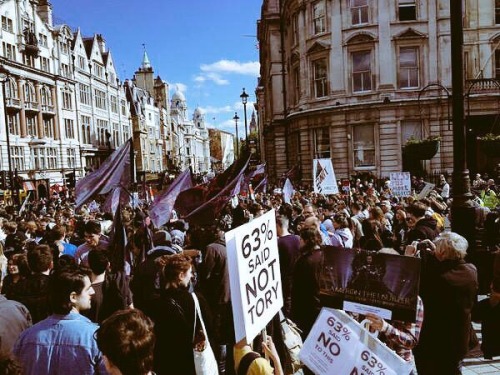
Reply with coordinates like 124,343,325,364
151,288,213,375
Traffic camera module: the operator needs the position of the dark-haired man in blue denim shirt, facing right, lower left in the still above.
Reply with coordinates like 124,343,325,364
13,269,107,375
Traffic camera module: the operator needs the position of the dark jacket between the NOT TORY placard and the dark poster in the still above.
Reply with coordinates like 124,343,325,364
292,249,323,339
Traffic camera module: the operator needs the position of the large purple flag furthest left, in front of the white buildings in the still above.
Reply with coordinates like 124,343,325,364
76,139,132,208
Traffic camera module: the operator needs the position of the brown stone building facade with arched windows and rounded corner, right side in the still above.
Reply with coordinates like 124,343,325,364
256,0,500,182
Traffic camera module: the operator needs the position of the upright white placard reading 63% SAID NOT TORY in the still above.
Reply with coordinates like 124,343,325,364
226,210,283,342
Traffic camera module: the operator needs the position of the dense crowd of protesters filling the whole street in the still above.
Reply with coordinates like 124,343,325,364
0,176,500,375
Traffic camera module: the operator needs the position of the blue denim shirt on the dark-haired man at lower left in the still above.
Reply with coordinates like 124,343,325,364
13,313,107,375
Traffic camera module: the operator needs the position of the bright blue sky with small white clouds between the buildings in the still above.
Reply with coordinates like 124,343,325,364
51,0,262,137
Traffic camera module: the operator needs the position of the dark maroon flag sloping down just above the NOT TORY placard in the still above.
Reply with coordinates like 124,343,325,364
185,158,250,225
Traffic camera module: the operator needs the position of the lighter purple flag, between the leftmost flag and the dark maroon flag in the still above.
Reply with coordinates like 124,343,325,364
149,168,193,228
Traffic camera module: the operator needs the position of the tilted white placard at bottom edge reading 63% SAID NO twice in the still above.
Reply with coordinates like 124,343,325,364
299,308,411,375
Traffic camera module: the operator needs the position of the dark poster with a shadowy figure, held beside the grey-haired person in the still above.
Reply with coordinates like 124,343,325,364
320,246,420,322
